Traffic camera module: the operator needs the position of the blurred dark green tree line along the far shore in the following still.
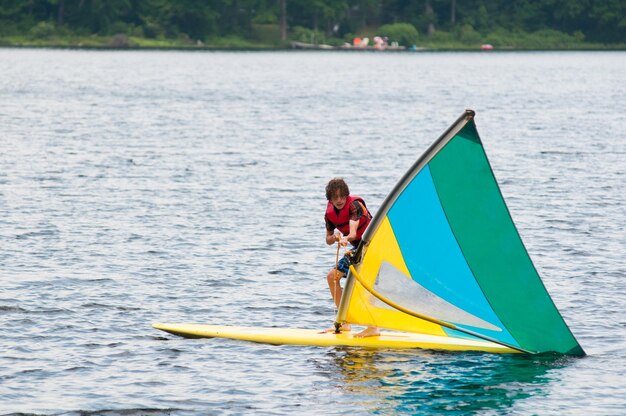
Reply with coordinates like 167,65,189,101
0,0,626,44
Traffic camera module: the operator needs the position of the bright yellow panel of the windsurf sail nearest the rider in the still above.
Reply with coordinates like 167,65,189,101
342,217,447,336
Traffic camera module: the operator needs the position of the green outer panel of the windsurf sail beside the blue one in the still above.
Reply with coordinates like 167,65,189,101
428,118,584,355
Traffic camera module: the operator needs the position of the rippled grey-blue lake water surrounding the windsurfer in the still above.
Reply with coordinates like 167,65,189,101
0,49,626,416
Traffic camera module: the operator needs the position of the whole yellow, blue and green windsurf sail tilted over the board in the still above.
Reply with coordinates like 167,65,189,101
336,110,585,356
